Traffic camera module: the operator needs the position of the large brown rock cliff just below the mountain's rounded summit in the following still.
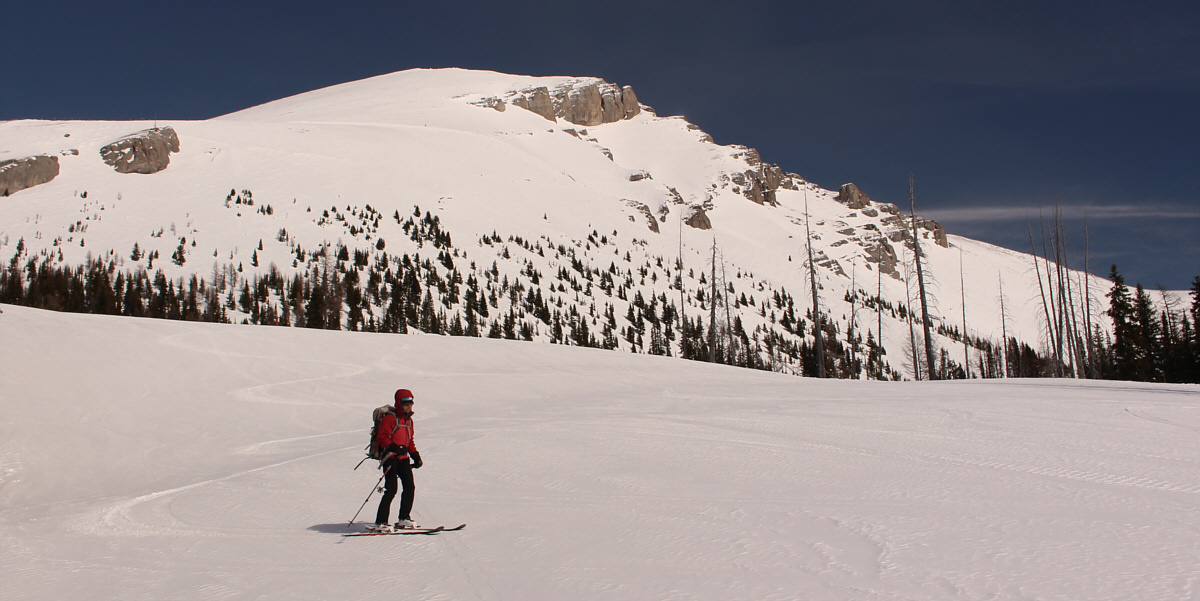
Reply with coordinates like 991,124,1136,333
509,79,642,126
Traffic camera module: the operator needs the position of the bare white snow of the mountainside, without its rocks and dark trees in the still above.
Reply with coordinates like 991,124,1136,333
0,70,1166,373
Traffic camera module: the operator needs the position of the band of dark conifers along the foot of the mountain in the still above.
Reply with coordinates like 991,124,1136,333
0,214,1200,381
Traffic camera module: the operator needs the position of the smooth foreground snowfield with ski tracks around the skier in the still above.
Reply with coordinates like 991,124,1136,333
0,306,1200,601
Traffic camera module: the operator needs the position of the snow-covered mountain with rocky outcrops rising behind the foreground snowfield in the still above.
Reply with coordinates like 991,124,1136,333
0,70,1110,377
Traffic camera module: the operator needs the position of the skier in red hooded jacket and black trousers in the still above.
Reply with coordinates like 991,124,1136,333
376,389,422,528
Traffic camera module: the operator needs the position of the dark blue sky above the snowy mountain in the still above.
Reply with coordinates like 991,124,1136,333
7,0,1200,289
